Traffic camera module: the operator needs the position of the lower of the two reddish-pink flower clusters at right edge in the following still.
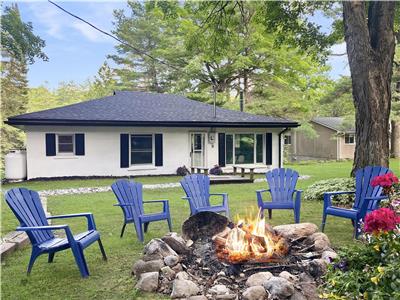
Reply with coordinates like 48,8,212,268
364,207,400,233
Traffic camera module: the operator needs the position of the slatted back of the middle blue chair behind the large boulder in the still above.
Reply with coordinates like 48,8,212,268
181,174,211,208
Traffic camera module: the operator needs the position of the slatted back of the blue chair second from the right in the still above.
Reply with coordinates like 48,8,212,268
265,168,299,202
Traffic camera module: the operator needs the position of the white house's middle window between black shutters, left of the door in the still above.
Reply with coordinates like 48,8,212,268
131,134,153,165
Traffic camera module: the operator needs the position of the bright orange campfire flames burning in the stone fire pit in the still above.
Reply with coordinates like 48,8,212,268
213,214,288,263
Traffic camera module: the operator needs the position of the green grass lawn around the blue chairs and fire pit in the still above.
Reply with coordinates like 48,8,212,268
1,160,399,299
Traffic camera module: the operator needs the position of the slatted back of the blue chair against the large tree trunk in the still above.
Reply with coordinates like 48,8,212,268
353,166,390,209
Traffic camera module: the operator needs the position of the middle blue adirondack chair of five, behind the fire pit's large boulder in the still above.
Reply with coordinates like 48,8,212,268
181,174,229,218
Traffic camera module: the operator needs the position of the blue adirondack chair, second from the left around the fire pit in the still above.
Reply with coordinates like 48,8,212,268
111,179,172,243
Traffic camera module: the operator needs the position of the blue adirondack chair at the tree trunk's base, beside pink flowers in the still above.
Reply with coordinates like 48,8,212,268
321,166,390,238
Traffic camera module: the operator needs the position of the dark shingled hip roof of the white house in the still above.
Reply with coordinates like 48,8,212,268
6,92,299,127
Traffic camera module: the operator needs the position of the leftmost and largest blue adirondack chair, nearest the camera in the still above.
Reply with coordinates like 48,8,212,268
5,188,107,277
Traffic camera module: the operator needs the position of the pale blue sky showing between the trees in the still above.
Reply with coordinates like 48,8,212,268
3,1,349,88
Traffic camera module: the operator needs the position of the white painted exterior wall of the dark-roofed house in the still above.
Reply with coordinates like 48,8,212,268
25,126,283,179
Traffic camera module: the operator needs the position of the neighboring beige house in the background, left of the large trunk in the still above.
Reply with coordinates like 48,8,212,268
284,117,355,161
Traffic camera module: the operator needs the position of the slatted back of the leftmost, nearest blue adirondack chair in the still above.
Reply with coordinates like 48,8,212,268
5,188,54,245
